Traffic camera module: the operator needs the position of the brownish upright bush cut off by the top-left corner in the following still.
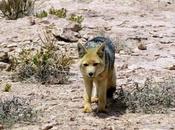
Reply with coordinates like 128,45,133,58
0,0,34,20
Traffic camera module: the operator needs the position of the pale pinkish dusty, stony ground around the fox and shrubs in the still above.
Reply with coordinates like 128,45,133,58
0,0,175,130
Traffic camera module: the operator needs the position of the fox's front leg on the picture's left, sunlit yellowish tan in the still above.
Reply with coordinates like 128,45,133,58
83,78,93,113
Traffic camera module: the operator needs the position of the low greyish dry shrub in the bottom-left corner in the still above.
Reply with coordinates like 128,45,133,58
0,96,37,127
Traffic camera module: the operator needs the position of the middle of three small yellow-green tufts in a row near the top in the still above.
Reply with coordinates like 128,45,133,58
49,8,67,18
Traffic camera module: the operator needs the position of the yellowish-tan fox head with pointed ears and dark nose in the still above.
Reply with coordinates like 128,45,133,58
78,43,105,78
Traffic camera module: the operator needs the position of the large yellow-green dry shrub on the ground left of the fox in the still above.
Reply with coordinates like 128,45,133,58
13,27,72,84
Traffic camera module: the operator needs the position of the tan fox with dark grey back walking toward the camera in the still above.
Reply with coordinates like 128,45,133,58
77,36,116,113
